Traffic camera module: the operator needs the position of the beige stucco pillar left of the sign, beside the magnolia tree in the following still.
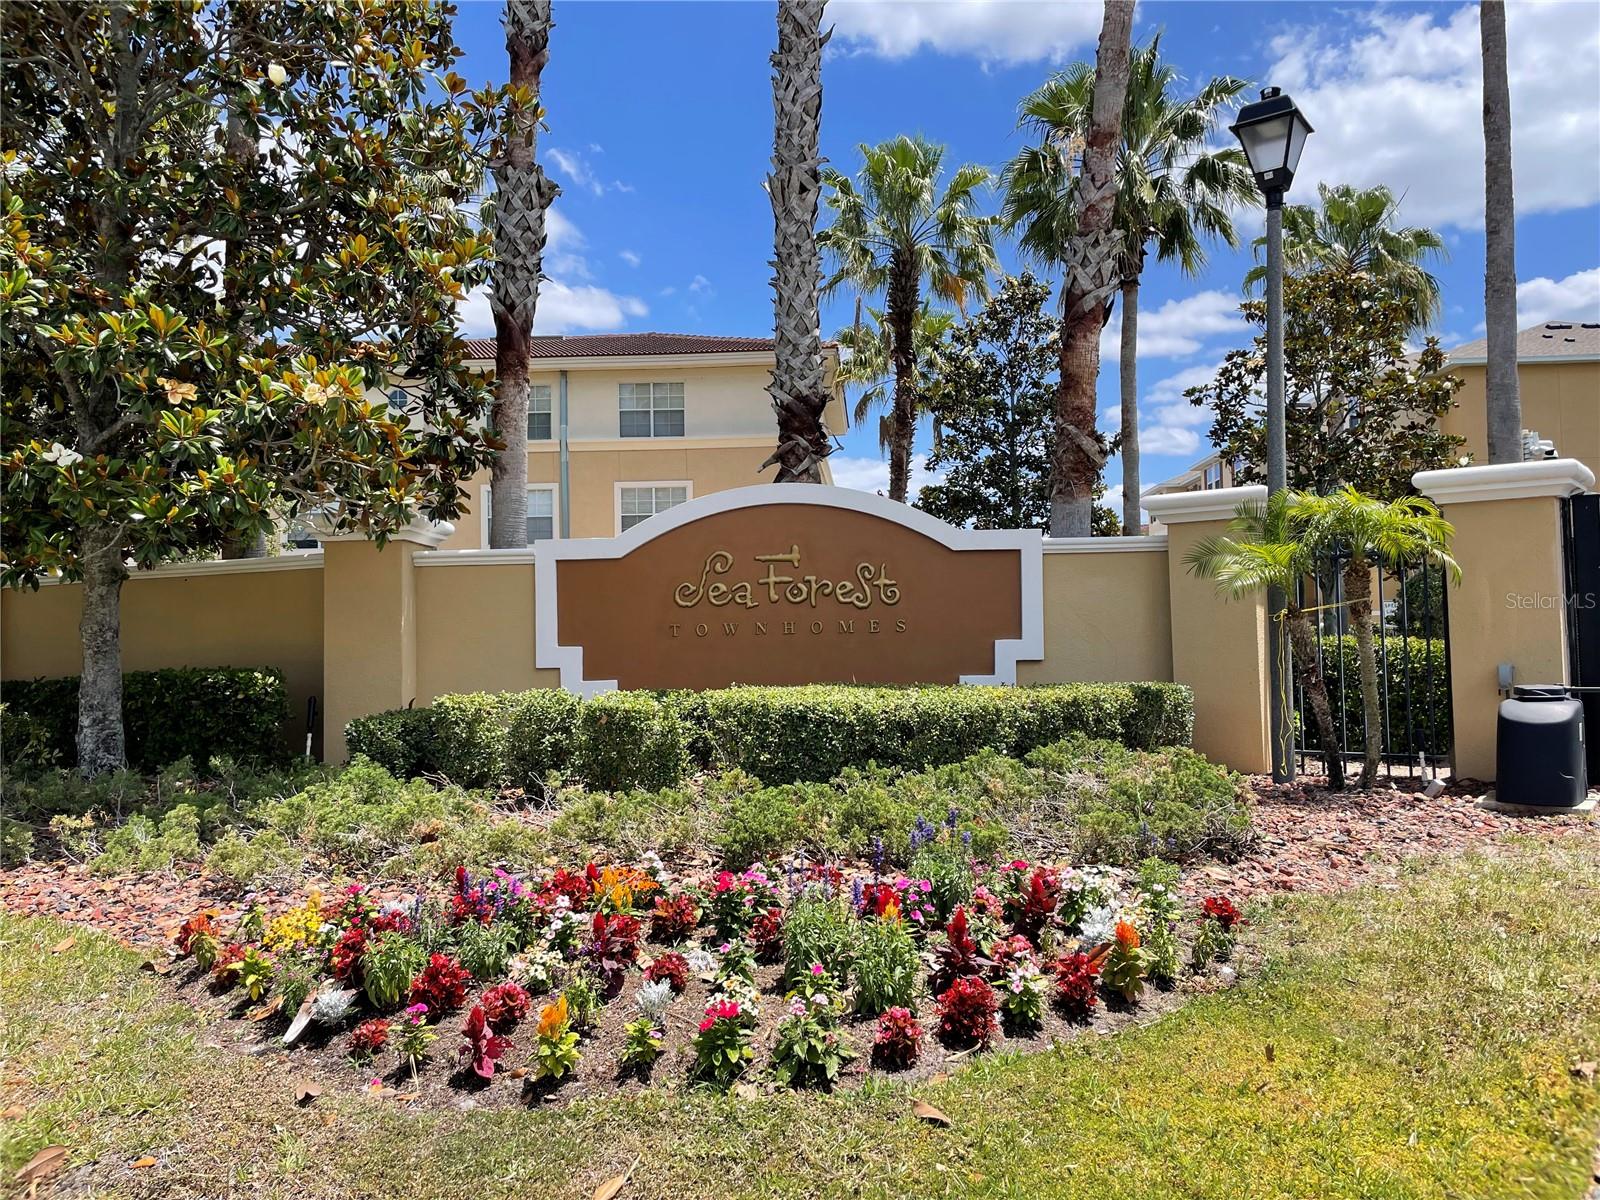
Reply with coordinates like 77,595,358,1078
322,522,454,763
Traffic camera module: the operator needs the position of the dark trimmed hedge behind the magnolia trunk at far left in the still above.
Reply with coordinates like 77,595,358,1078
5,667,290,771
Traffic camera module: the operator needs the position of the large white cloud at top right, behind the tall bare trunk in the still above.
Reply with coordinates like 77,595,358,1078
1266,3,1600,229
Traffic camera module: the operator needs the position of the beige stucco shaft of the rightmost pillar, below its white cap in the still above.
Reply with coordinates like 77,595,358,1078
1443,496,1570,779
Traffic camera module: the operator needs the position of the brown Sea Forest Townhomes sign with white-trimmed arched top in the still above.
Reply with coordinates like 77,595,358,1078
534,483,1045,694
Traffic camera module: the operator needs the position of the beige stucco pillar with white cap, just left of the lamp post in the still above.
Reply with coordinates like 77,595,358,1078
1144,485,1272,774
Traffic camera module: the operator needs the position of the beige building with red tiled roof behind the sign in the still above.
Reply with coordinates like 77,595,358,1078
376,333,846,550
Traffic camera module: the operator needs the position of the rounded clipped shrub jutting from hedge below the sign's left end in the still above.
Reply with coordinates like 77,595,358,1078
573,691,690,792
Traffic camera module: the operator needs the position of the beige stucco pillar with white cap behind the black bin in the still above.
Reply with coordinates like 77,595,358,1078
1411,458,1595,781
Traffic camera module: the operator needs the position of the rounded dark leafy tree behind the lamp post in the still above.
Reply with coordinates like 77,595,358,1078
1186,270,1464,501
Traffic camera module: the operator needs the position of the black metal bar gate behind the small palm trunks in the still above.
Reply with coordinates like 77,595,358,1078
1294,557,1459,781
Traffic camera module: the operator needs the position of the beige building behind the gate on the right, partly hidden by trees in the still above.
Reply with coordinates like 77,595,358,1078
1142,322,1600,518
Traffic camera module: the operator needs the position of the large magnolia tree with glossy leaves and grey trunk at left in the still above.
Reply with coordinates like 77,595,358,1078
0,0,504,773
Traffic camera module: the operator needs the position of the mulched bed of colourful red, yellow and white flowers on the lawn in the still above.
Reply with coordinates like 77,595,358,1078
162,829,1240,1104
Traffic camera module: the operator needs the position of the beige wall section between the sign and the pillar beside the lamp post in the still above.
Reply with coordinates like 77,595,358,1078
1016,549,1173,683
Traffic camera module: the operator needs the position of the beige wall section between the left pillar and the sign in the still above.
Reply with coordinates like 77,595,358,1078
416,563,562,704
